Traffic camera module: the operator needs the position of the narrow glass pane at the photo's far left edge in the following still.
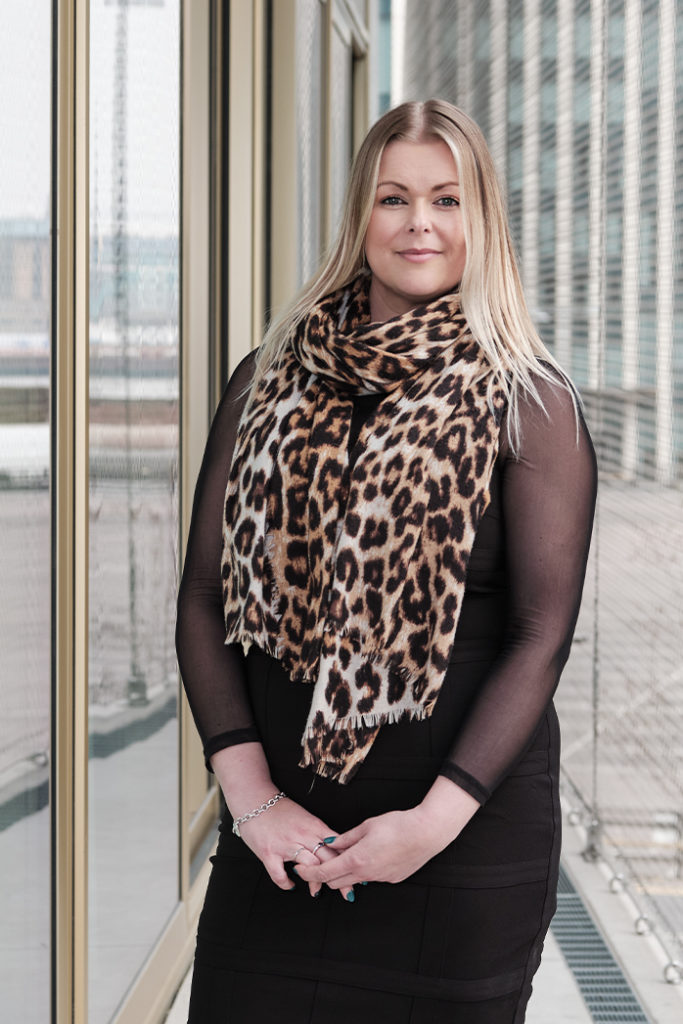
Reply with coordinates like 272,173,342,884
0,0,51,1024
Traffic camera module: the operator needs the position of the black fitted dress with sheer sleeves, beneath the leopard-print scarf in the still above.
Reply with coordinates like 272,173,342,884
178,356,596,1024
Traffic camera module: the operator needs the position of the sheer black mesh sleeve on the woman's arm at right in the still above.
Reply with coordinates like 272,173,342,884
441,384,597,803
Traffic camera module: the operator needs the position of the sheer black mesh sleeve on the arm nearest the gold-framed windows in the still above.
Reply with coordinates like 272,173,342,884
176,353,259,767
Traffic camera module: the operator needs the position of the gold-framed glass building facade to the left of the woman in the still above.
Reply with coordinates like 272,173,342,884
0,0,380,1024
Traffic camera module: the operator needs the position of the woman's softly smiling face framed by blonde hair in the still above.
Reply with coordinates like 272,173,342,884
366,138,466,321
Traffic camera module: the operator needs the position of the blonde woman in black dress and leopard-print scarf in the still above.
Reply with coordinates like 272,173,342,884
178,100,596,1024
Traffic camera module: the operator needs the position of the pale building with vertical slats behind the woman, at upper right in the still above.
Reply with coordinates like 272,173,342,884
393,0,683,482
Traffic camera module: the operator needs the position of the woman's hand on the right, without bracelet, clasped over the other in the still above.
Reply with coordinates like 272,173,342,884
299,776,479,891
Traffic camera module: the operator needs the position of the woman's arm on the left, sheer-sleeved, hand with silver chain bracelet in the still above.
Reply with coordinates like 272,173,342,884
176,354,349,896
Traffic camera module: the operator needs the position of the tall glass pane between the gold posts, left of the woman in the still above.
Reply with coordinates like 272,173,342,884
88,0,180,1024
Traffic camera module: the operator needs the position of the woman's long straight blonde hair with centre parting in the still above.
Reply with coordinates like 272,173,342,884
252,99,578,451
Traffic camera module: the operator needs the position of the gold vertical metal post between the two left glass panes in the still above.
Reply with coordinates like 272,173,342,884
50,0,89,1024
